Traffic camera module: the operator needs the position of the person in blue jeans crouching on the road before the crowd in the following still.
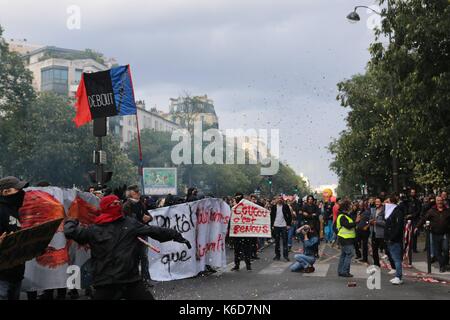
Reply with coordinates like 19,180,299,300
291,225,319,273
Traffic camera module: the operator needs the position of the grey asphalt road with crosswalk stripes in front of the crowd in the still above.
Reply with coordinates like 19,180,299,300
153,240,450,300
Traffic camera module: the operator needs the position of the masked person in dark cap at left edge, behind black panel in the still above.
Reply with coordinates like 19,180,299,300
0,177,28,300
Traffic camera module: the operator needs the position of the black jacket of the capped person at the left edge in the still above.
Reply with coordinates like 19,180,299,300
0,196,25,282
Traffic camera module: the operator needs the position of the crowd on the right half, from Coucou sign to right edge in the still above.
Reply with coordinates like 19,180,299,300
224,189,450,285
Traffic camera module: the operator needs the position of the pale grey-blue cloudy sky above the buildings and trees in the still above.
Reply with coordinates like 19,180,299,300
0,0,375,186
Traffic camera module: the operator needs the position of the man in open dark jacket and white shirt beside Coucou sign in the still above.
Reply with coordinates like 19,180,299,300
270,196,292,261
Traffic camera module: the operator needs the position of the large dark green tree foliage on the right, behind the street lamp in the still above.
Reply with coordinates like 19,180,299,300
330,0,450,194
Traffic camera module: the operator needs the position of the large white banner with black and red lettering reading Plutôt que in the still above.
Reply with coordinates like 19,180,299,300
148,198,231,281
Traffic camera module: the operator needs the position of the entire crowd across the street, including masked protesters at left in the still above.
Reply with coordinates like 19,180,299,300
0,177,450,299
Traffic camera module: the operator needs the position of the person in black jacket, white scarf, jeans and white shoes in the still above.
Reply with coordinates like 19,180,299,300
384,195,405,285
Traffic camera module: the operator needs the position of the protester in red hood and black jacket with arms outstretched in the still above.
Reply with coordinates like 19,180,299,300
64,195,191,300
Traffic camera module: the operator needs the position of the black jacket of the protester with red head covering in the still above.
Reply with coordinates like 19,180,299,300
64,217,181,286
